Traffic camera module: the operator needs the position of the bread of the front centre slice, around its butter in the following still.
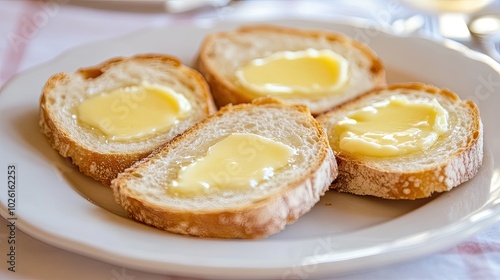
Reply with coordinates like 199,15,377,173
111,98,337,238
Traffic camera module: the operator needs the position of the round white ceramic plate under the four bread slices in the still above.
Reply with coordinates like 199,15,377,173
0,21,500,279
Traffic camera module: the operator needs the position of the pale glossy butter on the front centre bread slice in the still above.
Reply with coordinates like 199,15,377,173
167,133,295,196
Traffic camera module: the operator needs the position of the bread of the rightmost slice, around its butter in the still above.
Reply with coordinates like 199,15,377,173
317,83,483,199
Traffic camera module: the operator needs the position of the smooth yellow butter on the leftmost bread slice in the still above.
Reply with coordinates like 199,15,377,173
76,82,191,141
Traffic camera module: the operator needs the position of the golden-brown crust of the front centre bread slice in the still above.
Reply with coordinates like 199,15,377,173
112,98,337,239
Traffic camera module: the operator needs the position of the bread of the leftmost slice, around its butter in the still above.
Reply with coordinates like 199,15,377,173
40,54,216,185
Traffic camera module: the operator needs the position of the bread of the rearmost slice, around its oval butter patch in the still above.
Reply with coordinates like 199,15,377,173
195,25,386,115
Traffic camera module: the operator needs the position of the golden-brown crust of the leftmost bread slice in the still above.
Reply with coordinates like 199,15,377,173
39,54,216,186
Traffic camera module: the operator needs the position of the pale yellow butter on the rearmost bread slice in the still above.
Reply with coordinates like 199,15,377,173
236,49,348,98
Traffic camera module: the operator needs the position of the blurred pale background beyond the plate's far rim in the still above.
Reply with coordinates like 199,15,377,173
0,0,500,85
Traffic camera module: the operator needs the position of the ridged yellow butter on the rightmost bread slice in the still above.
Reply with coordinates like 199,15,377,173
332,95,448,157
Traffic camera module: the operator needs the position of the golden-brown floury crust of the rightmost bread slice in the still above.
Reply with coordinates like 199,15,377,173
317,83,483,200
